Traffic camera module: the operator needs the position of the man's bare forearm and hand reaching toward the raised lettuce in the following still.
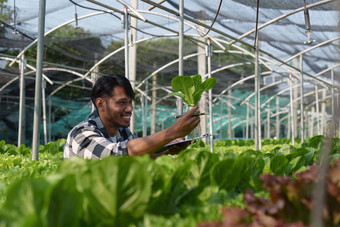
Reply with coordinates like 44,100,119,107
127,106,200,156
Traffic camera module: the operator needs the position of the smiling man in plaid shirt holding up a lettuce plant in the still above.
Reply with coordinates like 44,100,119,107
63,75,200,159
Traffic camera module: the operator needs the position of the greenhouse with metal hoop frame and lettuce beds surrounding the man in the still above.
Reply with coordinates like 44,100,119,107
0,0,340,226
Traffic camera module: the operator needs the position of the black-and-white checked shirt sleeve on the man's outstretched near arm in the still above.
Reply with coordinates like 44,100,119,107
64,126,130,159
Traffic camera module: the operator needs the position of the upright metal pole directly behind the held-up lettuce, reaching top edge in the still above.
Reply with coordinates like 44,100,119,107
177,0,184,114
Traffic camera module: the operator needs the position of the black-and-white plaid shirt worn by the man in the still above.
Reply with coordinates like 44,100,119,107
63,110,137,159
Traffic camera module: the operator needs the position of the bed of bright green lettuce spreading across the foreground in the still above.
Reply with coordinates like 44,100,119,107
0,137,340,227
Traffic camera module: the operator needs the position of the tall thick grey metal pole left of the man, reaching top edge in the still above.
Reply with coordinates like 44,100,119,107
32,0,46,160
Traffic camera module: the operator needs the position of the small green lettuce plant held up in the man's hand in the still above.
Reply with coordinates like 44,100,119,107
170,74,216,106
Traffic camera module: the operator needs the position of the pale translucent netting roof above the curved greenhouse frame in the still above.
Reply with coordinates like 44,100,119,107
3,0,339,82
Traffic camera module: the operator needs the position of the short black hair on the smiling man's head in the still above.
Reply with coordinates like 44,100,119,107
91,75,135,106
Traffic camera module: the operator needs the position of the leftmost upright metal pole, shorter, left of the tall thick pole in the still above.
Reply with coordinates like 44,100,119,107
18,54,26,147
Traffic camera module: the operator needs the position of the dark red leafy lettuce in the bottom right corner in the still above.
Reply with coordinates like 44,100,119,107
198,159,340,227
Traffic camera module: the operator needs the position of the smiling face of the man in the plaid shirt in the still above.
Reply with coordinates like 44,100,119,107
101,86,133,129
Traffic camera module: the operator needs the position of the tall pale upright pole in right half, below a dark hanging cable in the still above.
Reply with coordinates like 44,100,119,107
255,36,261,150
